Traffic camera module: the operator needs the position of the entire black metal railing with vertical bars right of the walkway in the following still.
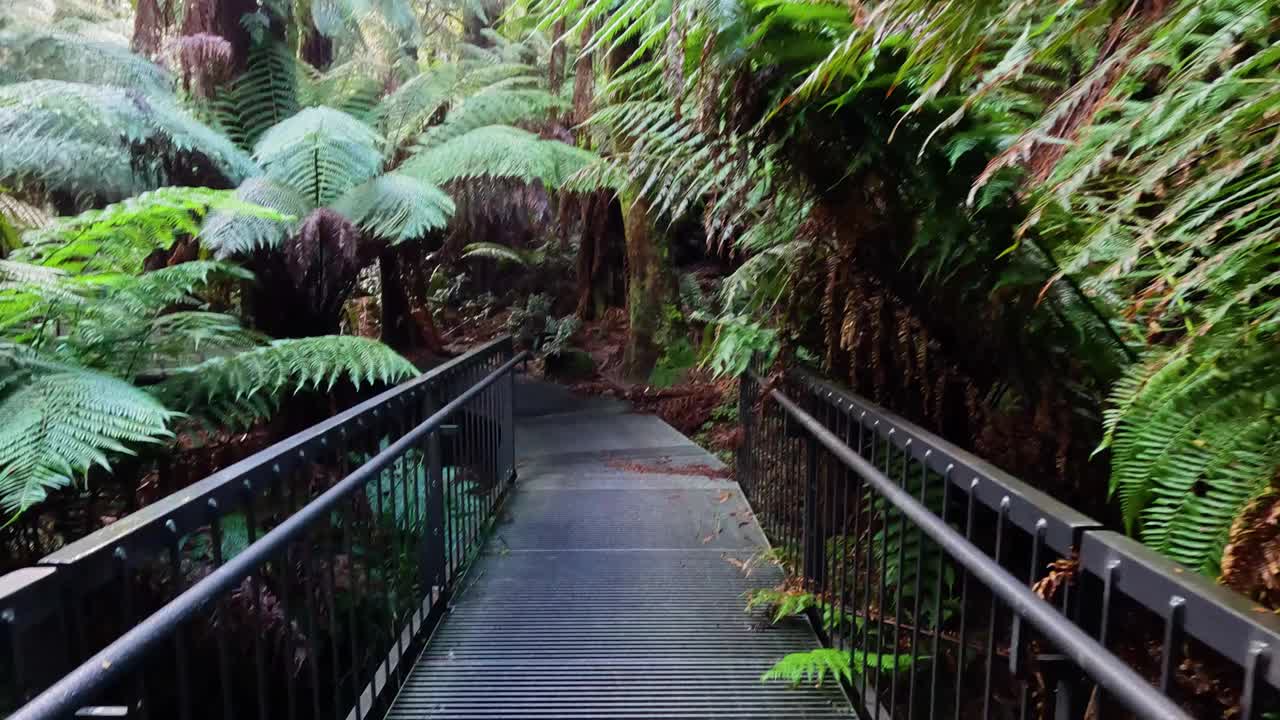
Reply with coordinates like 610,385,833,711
737,369,1280,720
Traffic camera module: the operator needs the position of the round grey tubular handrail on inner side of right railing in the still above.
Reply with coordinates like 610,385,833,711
769,389,1192,720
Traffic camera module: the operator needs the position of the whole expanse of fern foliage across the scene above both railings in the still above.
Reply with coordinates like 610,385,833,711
0,0,1280,607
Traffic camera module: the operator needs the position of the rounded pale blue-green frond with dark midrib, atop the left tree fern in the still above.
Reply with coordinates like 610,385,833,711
253,108,383,206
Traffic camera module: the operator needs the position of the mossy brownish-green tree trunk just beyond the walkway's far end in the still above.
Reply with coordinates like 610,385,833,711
622,188,678,383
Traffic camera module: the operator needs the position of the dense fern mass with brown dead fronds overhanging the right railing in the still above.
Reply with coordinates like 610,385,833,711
531,0,1280,589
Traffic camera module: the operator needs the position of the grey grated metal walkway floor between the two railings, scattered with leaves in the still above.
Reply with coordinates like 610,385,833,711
389,384,850,720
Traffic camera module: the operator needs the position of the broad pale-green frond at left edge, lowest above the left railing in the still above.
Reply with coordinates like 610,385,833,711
0,352,175,515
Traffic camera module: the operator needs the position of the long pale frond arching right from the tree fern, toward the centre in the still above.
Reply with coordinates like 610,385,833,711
399,126,595,188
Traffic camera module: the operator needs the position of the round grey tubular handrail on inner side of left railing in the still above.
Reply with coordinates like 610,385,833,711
9,352,527,720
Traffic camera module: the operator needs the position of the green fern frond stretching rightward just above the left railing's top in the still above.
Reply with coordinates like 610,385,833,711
155,336,417,425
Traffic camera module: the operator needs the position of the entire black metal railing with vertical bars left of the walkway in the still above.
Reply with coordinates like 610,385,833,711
0,338,524,720
